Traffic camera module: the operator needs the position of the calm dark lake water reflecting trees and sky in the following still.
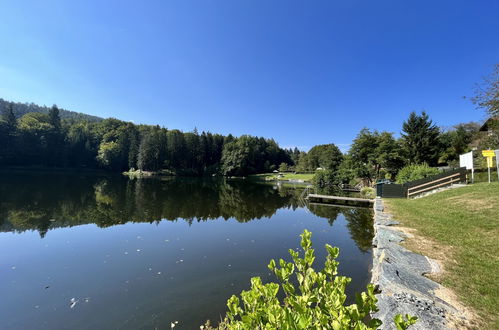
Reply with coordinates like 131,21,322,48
0,173,373,329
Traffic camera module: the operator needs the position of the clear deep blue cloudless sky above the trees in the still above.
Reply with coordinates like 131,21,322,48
0,0,499,150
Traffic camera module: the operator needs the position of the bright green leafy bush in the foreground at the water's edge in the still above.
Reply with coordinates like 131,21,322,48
201,230,416,330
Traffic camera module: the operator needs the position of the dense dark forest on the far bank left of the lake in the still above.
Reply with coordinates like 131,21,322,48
0,104,293,176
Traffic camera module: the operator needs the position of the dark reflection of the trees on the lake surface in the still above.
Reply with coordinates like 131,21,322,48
0,174,373,251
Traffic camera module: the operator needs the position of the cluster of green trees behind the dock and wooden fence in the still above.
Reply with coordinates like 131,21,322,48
315,111,480,187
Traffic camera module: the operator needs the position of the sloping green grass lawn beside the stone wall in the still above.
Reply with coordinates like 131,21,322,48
385,182,499,329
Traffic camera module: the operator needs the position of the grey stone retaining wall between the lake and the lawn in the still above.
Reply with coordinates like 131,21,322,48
371,198,465,329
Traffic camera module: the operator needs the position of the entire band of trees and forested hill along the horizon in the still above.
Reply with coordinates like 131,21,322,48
0,65,499,180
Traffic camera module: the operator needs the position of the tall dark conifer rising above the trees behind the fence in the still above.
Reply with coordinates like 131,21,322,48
402,111,440,165
